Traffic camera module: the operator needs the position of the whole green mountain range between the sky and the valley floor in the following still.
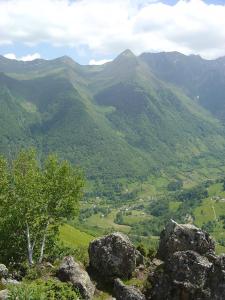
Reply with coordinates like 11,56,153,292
0,50,225,179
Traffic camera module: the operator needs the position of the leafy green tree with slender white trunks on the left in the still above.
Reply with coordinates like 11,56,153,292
0,150,84,265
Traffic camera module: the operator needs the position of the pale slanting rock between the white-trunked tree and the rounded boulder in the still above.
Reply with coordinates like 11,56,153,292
57,256,95,300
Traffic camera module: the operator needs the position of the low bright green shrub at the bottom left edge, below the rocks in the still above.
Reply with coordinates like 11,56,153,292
8,279,79,300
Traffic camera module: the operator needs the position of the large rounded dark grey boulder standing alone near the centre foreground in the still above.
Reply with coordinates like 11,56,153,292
88,233,136,280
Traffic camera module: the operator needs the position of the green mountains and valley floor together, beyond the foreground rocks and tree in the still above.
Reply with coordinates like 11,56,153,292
0,50,225,258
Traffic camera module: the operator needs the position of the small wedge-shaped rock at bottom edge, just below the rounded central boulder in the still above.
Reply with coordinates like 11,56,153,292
113,278,146,300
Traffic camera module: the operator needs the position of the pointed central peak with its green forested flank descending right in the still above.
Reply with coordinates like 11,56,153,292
90,52,224,166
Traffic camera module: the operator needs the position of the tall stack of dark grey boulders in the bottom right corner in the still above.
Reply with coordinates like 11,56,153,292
147,221,225,300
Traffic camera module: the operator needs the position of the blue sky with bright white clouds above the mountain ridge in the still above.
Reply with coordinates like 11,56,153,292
0,0,225,64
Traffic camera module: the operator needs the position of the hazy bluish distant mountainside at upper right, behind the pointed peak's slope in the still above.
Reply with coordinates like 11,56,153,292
140,52,225,122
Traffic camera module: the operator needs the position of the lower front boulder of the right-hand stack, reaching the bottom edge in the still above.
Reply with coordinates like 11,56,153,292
150,250,213,300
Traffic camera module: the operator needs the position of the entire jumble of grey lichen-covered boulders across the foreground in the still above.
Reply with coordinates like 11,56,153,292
0,220,225,300
